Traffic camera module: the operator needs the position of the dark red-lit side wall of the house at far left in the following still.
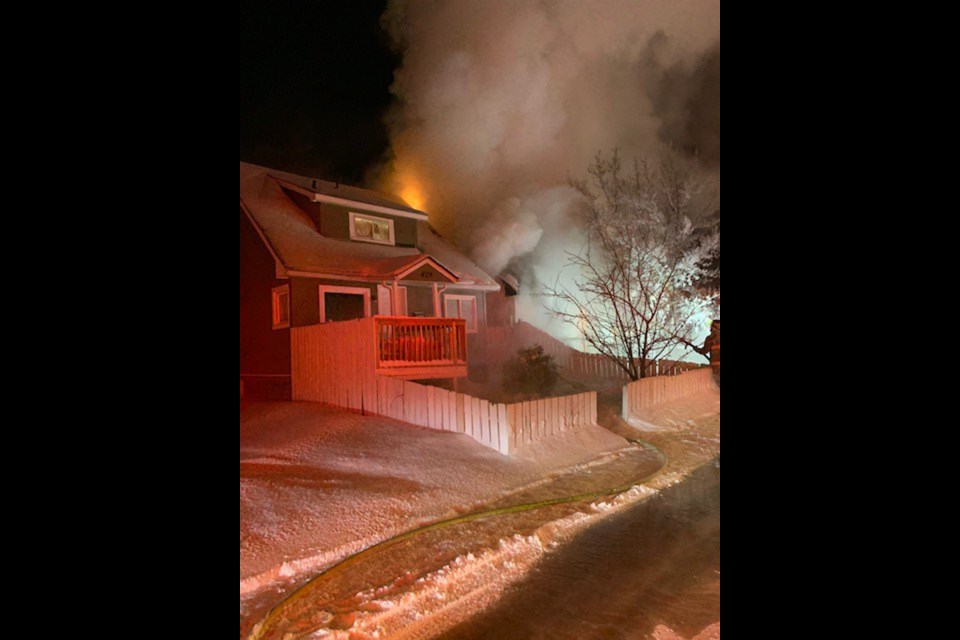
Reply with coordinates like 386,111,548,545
240,209,290,399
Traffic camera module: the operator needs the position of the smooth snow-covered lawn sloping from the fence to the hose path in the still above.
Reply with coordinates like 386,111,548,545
240,402,627,609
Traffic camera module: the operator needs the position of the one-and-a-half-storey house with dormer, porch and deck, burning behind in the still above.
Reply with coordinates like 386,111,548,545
240,162,506,398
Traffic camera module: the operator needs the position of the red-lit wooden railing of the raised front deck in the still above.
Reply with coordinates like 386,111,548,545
376,316,467,368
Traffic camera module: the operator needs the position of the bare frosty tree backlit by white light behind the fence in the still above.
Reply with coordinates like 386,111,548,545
546,149,719,380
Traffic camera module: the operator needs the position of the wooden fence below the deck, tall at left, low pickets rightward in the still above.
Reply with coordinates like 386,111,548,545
290,318,597,455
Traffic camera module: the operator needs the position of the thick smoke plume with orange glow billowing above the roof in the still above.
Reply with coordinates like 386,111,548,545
380,0,720,338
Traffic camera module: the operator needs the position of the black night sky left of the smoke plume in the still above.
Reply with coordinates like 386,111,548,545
240,1,399,184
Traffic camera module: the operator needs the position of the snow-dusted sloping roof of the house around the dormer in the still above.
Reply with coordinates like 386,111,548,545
240,162,499,289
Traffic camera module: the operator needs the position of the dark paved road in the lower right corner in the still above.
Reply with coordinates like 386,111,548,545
442,460,720,640
